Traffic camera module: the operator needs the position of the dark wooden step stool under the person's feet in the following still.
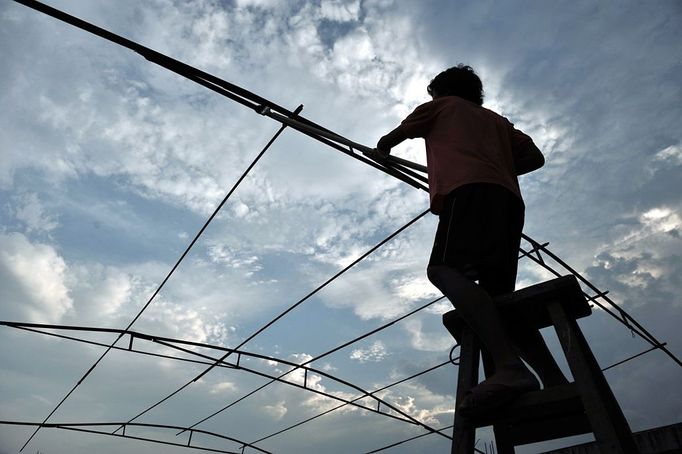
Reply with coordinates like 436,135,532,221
443,276,638,454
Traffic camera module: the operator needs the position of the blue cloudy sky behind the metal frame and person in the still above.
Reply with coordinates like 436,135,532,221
0,0,682,454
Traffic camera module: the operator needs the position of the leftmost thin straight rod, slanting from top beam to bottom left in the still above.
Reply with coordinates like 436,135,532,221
19,116,294,452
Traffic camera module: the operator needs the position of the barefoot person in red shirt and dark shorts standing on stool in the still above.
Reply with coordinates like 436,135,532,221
372,64,567,416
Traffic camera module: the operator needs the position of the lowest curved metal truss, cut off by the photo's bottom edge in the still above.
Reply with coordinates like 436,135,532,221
0,421,271,454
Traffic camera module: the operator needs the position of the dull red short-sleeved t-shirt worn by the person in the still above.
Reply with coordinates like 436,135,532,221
399,96,532,214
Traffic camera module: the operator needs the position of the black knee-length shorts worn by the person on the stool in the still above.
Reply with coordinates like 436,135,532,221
429,183,524,296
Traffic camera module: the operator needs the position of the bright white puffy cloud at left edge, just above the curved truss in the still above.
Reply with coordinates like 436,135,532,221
0,232,73,323
